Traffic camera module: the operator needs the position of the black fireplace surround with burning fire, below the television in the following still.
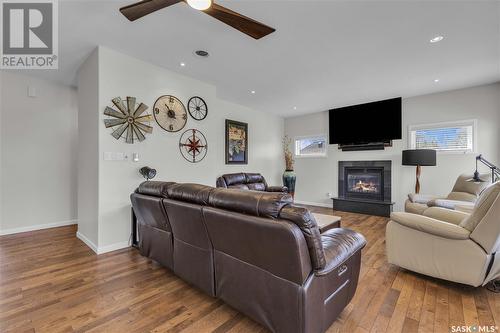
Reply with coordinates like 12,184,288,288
332,161,393,216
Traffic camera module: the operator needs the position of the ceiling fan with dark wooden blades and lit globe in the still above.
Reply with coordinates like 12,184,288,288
120,0,276,39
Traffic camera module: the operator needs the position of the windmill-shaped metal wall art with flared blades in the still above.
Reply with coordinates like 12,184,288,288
104,97,153,144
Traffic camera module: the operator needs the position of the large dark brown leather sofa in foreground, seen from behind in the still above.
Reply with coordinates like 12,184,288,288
131,181,366,333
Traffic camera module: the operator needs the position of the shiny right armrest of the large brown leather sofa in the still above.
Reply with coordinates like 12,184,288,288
315,228,366,276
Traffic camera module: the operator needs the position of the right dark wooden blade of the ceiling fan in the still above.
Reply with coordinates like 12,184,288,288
203,3,276,39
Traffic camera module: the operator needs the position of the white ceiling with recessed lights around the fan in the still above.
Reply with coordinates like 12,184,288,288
13,0,500,116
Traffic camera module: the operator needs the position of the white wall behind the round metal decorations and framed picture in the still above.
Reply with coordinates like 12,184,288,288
76,47,284,252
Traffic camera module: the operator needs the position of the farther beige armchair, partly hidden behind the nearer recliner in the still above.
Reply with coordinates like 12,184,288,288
405,174,490,215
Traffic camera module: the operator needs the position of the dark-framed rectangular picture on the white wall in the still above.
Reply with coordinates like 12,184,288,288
226,119,248,164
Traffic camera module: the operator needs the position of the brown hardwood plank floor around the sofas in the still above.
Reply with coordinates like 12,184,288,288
0,208,500,333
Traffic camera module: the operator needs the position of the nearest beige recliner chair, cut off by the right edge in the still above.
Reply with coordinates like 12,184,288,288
386,182,500,287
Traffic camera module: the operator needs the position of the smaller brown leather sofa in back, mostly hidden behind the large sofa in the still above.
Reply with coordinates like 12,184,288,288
216,173,288,193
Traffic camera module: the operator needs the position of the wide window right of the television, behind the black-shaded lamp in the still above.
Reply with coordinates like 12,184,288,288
409,120,476,153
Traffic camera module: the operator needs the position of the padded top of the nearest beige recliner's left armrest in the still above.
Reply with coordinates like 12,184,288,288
391,212,470,239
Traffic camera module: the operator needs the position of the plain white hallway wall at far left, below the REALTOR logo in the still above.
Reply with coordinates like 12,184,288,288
0,72,78,234
